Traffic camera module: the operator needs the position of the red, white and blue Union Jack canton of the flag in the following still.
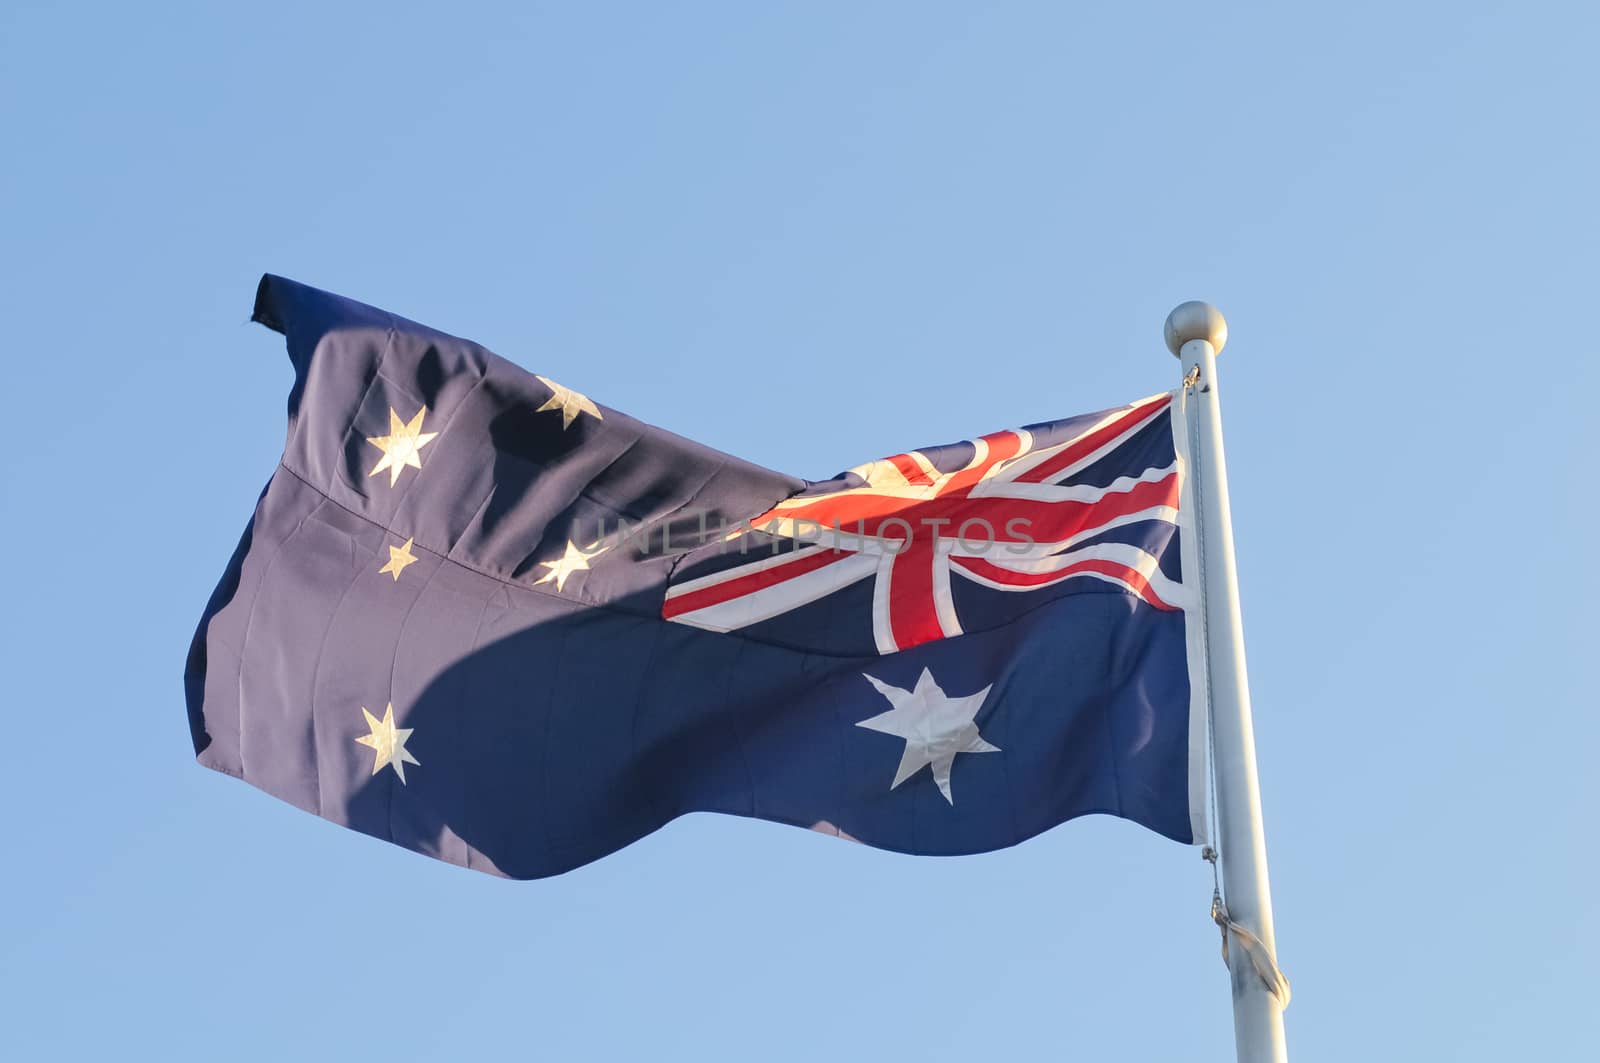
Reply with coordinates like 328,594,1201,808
662,394,1187,653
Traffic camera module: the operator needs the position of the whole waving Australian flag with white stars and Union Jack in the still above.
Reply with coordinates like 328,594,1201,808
184,275,1205,877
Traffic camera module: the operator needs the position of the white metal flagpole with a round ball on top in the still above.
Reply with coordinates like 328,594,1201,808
1165,303,1288,1063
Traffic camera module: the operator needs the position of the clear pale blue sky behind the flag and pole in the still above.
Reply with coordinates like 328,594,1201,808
0,0,1600,1060
